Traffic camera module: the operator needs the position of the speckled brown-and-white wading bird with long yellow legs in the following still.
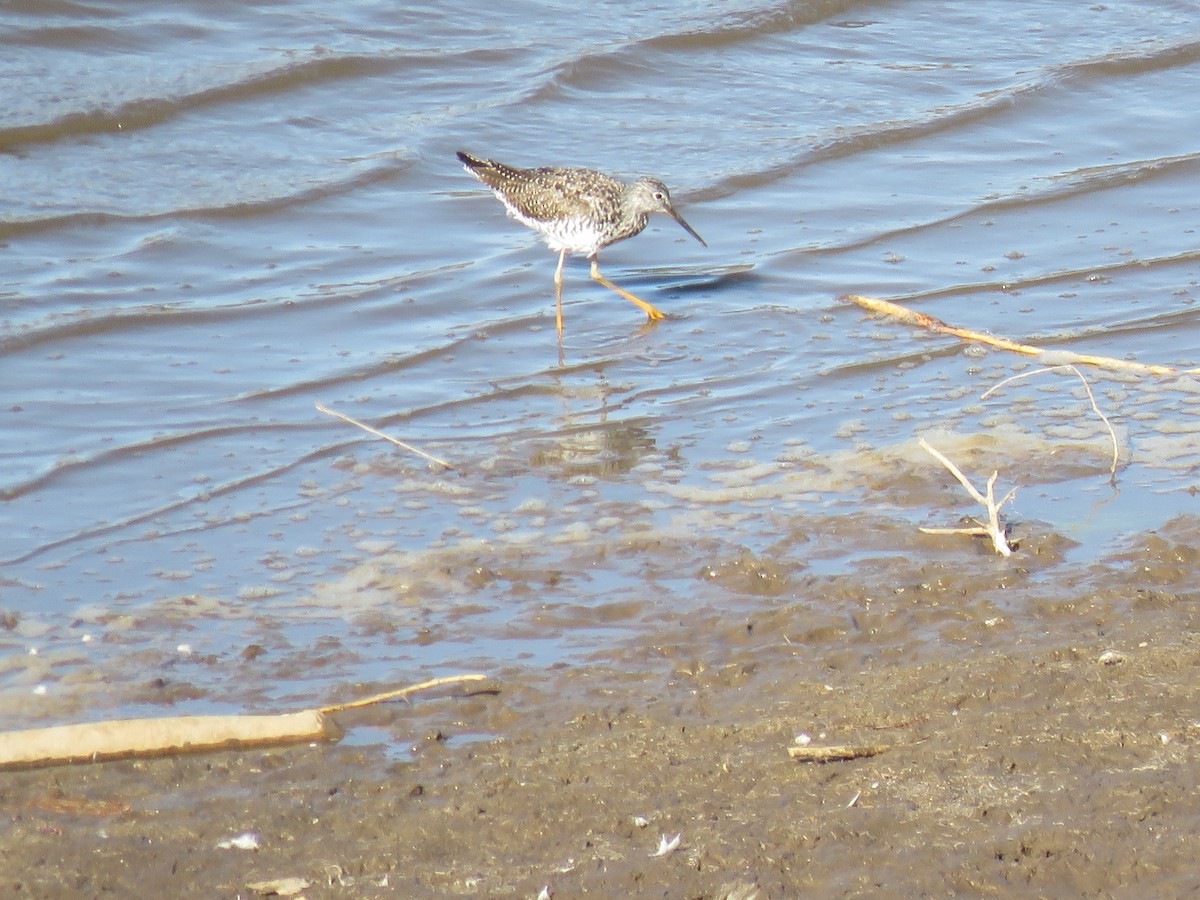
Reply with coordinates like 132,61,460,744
458,151,708,335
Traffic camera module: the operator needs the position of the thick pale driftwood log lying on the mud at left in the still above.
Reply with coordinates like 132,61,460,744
0,709,342,769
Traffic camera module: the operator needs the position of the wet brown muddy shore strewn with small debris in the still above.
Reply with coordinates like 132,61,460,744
0,520,1200,900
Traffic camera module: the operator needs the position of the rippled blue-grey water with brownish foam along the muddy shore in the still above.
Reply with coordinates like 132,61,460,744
0,0,1200,716
